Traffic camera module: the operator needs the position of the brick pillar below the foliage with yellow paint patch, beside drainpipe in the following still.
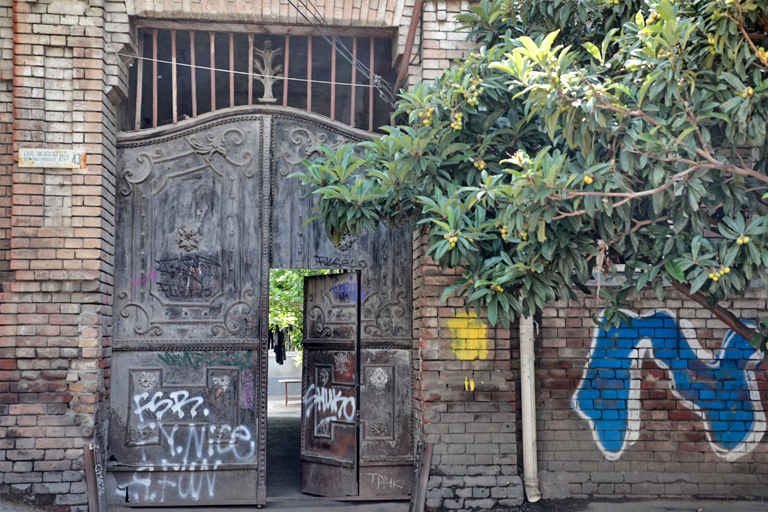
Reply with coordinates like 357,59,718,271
413,230,523,510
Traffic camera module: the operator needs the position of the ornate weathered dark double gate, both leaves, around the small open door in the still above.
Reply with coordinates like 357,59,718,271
107,107,413,505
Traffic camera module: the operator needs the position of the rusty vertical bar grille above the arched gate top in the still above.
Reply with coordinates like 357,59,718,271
130,27,395,131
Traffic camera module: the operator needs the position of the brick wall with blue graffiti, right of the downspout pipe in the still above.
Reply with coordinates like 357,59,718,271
536,290,768,498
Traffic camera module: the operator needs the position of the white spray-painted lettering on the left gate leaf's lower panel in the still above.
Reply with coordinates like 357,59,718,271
117,364,257,502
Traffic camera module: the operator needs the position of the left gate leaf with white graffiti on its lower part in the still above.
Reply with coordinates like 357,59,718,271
108,115,269,505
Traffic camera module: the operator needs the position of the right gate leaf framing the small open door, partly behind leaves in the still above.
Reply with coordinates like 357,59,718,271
271,113,413,496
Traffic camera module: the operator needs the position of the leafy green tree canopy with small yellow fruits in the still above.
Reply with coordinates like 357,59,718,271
294,0,768,350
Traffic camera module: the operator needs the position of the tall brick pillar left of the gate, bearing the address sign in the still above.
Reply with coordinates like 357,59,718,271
0,1,120,510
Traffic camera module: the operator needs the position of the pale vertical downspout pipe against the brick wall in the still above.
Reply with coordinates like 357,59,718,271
520,316,541,503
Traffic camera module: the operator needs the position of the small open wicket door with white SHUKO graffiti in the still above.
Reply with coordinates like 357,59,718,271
301,272,360,496
